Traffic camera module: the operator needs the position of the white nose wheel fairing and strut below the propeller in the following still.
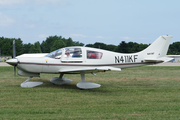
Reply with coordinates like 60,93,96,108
21,77,43,88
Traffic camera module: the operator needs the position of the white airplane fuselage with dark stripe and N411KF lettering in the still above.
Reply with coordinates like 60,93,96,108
17,46,158,73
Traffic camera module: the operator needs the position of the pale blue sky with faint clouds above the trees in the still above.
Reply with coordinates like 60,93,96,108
0,0,180,45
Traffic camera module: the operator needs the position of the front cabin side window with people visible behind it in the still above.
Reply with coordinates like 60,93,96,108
65,48,82,58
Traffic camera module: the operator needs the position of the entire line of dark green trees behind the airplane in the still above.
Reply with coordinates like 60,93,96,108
0,35,180,56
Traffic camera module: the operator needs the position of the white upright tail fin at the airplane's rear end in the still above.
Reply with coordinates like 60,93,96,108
141,36,172,61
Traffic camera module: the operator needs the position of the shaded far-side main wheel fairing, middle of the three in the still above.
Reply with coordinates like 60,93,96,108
50,74,72,85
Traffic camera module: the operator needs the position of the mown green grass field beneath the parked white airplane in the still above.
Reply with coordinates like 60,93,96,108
0,66,180,120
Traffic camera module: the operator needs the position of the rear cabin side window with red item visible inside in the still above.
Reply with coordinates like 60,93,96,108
87,50,103,59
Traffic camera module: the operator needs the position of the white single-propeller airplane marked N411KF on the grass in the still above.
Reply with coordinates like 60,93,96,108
6,35,173,89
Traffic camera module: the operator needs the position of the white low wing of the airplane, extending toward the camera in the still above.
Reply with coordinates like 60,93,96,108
59,66,121,72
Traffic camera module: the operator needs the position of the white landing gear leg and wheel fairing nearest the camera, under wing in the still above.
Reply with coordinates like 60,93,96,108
76,72,101,89
